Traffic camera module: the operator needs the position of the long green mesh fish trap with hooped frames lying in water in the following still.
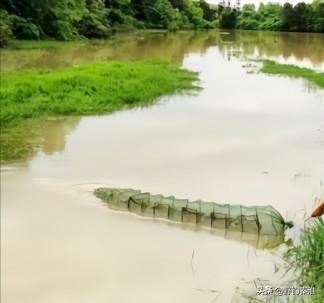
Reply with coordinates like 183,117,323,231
95,188,289,235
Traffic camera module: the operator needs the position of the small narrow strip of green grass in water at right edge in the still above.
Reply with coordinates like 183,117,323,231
261,60,324,88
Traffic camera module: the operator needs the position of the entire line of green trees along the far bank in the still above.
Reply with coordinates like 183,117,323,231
0,0,324,46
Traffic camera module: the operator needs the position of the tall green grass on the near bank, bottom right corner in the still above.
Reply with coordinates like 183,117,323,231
286,219,324,303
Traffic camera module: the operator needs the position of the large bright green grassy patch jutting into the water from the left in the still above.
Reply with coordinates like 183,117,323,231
0,60,198,160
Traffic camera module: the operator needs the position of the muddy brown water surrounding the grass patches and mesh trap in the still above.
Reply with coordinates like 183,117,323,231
1,32,324,303
